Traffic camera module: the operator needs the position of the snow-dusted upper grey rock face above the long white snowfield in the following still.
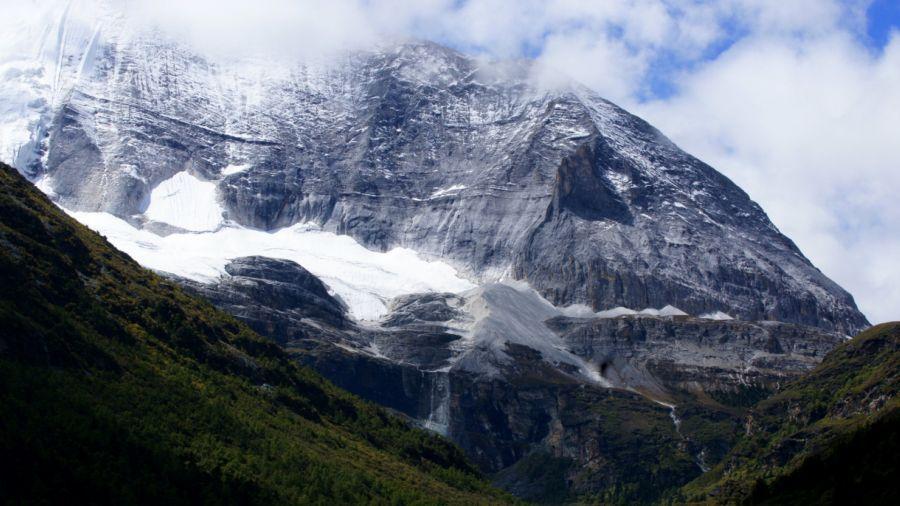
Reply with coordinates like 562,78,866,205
14,11,867,333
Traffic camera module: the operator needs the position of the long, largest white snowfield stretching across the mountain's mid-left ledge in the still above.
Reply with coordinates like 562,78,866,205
67,211,474,320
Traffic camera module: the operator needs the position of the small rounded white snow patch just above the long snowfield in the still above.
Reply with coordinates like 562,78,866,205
144,171,224,232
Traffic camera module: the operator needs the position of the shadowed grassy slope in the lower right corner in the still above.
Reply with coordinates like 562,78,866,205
684,323,900,504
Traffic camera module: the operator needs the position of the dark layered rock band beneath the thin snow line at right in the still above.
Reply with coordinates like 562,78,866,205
548,317,842,399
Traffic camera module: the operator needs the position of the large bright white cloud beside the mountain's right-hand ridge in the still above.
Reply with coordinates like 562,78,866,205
638,31,900,321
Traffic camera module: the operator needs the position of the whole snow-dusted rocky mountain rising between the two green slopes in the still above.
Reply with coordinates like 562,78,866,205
0,0,868,503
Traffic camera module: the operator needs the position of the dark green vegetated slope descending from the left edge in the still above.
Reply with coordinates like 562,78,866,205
0,166,509,504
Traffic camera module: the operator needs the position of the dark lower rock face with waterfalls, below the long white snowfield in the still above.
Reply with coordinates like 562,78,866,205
172,257,842,502
